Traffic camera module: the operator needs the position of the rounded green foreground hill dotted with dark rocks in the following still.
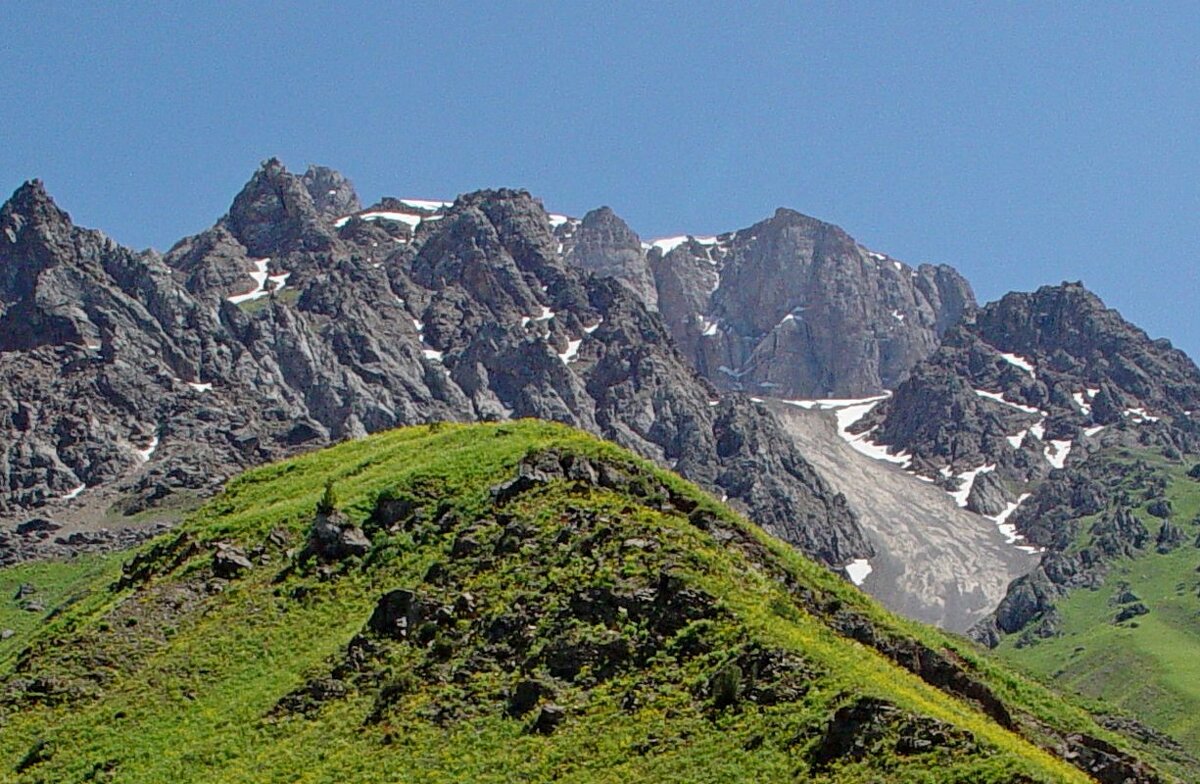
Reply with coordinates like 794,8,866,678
0,421,1180,784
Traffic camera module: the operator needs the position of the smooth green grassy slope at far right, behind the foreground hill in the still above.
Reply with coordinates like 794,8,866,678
997,453,1200,749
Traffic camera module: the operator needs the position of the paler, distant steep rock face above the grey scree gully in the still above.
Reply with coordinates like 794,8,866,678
568,209,974,399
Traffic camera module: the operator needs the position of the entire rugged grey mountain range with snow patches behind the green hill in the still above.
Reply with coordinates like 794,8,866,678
0,158,1200,768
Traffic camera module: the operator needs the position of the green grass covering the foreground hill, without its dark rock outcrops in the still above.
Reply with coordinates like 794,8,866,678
0,423,1161,783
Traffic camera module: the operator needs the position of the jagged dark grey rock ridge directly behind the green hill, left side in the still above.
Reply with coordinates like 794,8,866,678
0,165,871,564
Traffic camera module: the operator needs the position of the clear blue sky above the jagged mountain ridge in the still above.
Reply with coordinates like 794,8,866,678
0,1,1200,357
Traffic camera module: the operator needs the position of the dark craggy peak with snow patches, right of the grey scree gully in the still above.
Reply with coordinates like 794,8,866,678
854,283,1200,484
